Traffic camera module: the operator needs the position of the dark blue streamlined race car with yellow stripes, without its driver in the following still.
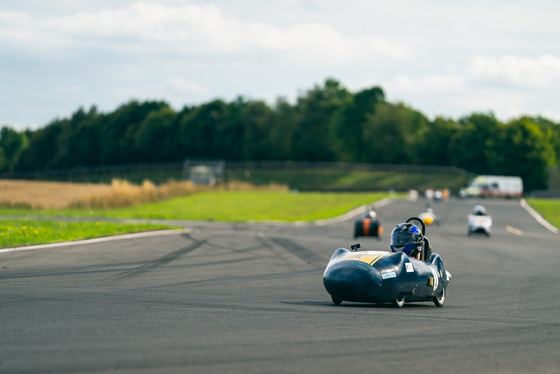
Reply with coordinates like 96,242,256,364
323,217,451,308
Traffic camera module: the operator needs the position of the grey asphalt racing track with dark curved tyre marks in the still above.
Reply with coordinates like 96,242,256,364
0,199,560,374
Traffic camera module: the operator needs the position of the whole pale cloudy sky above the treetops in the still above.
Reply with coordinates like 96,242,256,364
0,0,560,129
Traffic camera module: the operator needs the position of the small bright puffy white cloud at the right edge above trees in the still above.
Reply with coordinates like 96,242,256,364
470,54,560,89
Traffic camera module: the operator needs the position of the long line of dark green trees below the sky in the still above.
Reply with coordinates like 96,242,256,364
0,78,560,191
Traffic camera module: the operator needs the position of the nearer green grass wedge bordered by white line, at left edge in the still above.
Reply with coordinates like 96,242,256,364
0,218,181,248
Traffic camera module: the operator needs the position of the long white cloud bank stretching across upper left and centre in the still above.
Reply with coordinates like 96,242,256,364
0,2,411,64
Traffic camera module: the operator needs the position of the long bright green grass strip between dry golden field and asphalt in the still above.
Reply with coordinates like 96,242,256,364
0,191,389,222
